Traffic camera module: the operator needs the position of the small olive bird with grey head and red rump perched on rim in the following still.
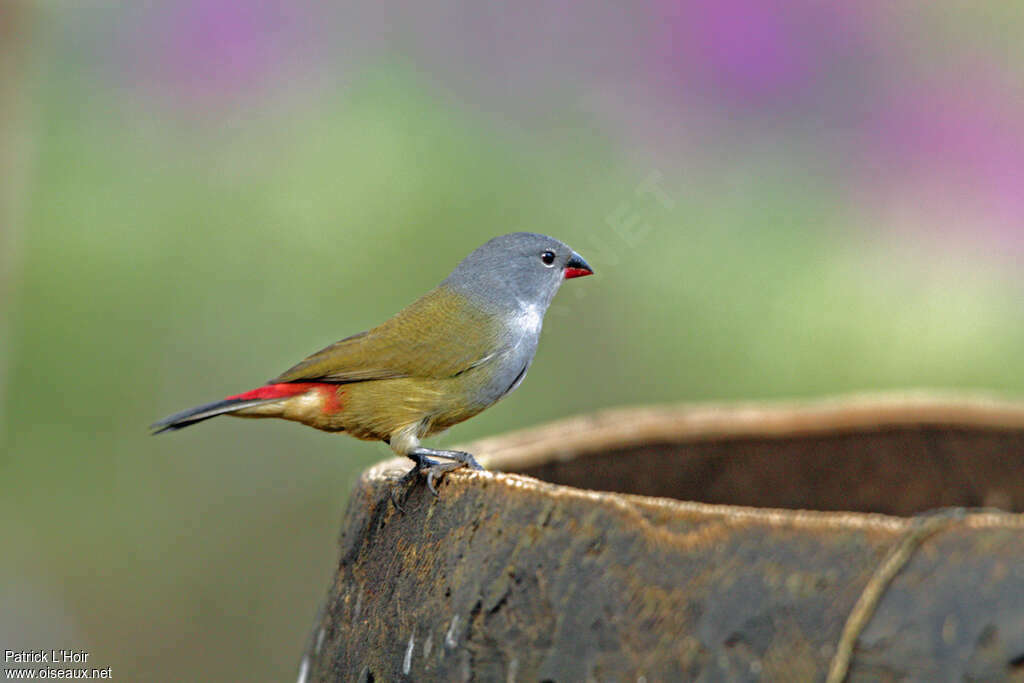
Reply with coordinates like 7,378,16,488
153,232,594,496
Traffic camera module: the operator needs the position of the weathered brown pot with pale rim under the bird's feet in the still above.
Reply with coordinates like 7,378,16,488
300,398,1024,682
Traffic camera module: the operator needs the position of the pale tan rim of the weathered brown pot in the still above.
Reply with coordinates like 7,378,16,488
359,391,1024,535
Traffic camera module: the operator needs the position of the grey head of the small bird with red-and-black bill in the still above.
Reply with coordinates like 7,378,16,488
441,232,594,315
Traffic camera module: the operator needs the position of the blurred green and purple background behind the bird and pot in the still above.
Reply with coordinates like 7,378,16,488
0,0,1024,681
